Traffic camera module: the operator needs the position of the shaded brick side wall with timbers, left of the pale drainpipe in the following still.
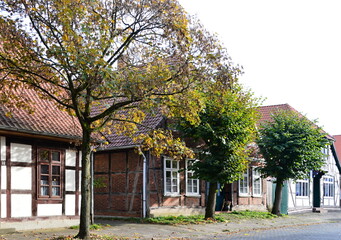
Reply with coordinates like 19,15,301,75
94,150,143,217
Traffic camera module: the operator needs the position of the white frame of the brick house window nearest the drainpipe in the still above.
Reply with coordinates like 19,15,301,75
163,157,180,196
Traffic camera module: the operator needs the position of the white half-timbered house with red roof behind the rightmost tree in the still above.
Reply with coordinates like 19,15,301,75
259,104,341,214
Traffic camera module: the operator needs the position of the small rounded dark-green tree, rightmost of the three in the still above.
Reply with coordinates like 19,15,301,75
256,111,329,215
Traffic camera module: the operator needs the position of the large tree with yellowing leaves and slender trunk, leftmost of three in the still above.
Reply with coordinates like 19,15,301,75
0,0,240,238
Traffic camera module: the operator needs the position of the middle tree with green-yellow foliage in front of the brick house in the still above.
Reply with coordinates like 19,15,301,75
178,85,258,219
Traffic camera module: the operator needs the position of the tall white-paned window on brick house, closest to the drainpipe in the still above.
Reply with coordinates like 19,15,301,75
164,158,180,195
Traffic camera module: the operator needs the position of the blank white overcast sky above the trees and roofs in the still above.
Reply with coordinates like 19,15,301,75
179,0,341,135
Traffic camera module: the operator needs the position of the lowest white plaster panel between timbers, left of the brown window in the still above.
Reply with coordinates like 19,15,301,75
11,194,32,217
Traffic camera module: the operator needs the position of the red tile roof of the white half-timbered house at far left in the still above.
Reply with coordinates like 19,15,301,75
0,89,82,139
